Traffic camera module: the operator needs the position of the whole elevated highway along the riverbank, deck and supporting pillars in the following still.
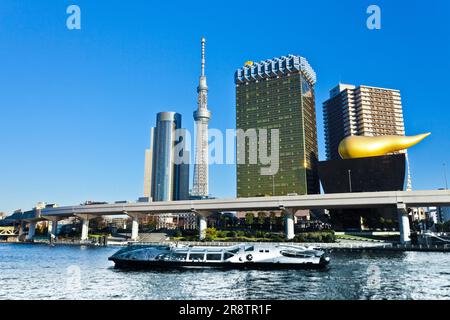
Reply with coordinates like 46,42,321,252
8,190,450,243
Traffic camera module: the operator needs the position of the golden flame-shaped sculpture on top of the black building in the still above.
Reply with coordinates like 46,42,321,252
338,133,431,159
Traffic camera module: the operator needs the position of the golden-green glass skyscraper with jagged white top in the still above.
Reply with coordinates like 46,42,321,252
235,55,320,197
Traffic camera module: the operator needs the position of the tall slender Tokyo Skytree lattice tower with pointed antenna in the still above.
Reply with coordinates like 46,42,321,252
192,38,211,197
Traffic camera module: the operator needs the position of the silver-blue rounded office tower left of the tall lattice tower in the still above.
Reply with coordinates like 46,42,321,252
144,112,189,201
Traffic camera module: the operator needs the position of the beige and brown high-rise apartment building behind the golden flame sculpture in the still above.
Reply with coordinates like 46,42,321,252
323,84,405,160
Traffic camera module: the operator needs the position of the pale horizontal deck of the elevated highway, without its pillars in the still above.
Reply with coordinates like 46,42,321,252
41,190,450,217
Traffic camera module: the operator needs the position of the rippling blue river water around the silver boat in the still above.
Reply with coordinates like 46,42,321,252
0,244,450,300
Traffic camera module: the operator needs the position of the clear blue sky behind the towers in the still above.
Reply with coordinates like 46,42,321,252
0,0,450,212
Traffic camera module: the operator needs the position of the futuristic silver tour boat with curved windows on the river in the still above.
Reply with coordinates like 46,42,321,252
109,243,330,269
